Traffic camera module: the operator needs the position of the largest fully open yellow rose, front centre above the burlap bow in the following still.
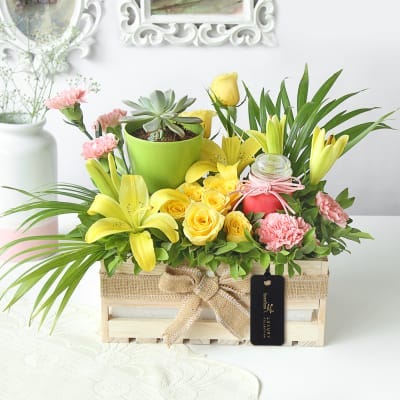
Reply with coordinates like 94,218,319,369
182,203,224,246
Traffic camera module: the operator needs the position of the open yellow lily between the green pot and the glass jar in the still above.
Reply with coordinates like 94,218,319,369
185,136,261,182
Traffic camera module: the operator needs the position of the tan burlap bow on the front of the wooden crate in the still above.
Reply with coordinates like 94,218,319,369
158,267,250,345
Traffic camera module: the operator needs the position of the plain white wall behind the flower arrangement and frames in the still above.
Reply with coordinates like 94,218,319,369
47,0,400,215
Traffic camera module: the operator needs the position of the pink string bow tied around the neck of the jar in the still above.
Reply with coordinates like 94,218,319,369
233,173,305,214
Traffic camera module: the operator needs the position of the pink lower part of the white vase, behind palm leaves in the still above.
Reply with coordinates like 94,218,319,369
0,219,58,261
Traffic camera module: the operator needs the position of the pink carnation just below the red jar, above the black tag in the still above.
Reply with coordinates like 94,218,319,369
257,213,311,252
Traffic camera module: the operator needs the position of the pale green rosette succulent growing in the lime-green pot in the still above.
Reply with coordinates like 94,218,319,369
122,90,202,140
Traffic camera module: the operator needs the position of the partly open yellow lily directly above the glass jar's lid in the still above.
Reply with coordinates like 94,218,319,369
246,115,286,154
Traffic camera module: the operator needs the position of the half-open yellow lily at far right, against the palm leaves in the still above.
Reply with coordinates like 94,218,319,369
310,127,349,185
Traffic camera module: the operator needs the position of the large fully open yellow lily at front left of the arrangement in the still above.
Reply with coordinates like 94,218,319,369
85,175,179,271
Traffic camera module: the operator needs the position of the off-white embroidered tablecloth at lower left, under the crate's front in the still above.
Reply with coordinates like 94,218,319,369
0,304,259,400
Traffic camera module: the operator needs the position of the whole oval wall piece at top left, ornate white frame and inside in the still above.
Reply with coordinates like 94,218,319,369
0,0,103,70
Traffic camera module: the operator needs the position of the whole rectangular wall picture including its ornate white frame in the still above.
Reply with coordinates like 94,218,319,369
120,0,276,46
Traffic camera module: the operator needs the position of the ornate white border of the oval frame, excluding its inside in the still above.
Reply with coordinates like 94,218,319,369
0,0,103,70
